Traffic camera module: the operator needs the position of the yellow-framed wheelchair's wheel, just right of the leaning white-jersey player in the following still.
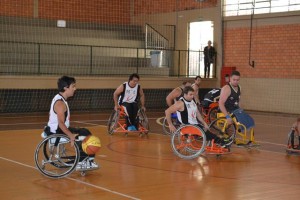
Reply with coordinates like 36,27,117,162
209,117,236,146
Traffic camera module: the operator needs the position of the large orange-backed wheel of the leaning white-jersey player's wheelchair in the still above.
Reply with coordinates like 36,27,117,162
171,125,206,159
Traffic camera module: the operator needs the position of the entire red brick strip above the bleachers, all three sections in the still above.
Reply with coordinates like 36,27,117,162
0,0,217,24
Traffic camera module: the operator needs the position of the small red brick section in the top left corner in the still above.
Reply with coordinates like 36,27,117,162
0,0,33,17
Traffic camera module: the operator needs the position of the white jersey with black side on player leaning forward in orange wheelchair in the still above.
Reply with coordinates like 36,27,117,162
177,97,199,124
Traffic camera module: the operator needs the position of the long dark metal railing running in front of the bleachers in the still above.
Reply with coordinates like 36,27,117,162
0,41,215,77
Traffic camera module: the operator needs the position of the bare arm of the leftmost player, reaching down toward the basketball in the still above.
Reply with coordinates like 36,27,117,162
54,101,76,146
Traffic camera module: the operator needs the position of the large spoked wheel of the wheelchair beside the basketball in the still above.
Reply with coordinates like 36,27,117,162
34,134,80,178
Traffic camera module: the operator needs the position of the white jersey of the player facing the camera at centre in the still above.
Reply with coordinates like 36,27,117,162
119,82,140,105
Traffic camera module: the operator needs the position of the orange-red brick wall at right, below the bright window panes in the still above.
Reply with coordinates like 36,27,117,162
224,24,300,78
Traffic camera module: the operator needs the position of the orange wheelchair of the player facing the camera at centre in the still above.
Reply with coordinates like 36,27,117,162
107,106,149,136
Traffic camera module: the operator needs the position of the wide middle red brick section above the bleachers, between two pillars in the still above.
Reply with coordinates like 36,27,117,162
39,0,130,24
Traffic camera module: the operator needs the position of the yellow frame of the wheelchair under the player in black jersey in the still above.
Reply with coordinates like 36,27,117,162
217,113,260,147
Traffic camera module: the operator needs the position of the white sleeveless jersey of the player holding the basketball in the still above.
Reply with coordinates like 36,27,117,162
48,94,70,133
